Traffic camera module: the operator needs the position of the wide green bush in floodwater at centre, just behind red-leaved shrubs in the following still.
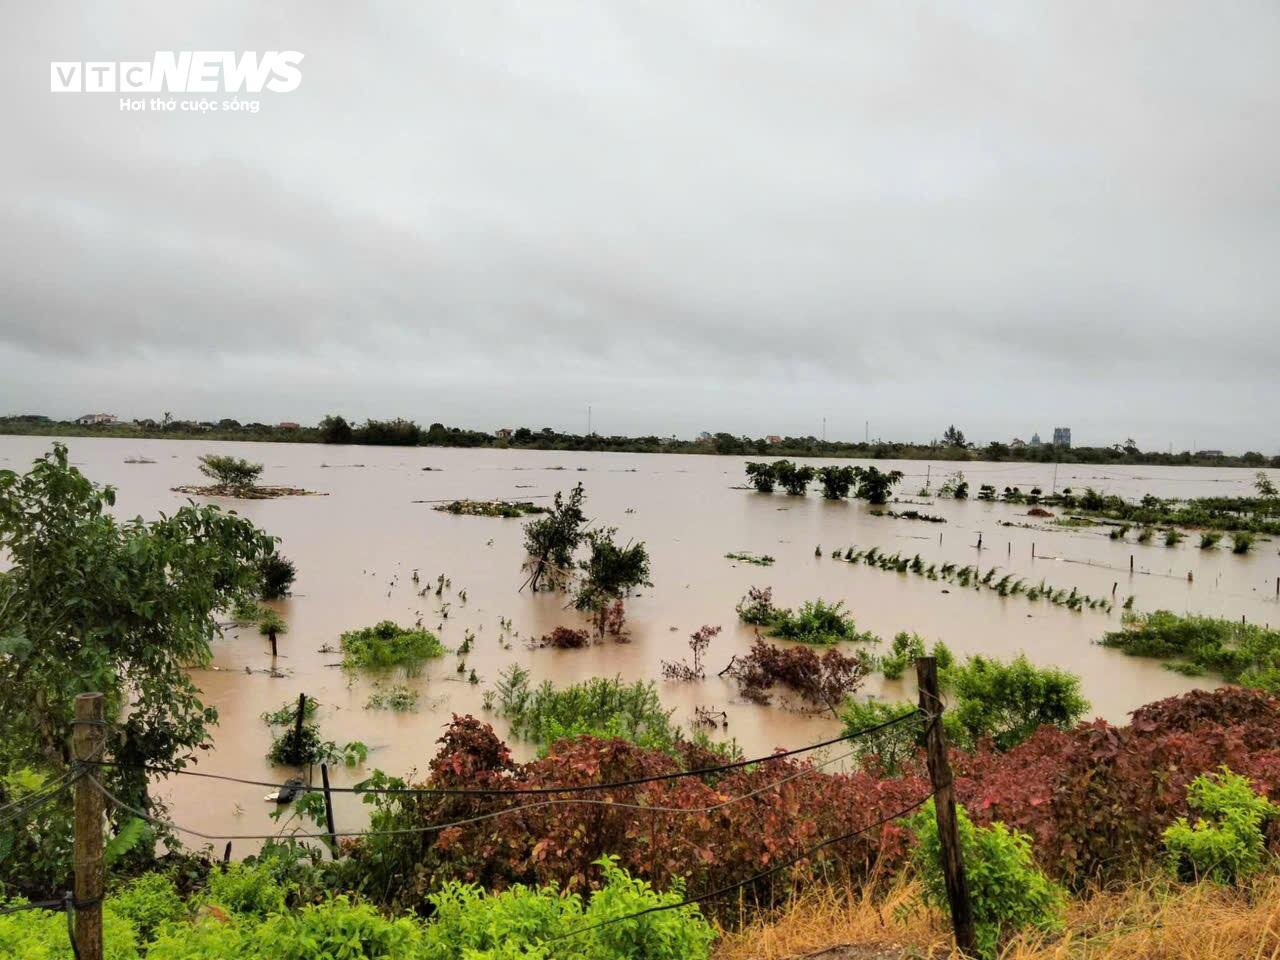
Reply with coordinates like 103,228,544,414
498,664,680,754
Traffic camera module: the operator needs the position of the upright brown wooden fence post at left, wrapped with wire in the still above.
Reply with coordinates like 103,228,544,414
72,694,106,960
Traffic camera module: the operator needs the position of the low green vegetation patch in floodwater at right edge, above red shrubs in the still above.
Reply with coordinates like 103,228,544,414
1098,611,1280,694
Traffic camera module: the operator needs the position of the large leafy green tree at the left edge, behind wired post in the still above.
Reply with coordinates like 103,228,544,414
0,444,274,892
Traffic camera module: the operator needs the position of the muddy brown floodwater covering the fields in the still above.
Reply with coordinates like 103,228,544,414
0,436,1280,855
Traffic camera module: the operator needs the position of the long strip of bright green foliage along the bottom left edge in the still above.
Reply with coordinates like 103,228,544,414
0,858,716,960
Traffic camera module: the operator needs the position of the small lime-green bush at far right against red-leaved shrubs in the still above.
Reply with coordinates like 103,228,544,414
1165,767,1280,883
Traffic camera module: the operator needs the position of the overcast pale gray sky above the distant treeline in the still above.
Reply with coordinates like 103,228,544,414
0,0,1280,453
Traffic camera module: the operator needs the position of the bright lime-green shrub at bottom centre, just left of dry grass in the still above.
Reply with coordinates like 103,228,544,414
419,856,716,960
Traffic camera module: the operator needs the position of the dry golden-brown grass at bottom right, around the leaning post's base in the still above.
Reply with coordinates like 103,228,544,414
713,874,1280,960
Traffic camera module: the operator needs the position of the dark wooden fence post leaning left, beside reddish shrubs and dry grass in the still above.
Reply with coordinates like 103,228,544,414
915,657,978,956
